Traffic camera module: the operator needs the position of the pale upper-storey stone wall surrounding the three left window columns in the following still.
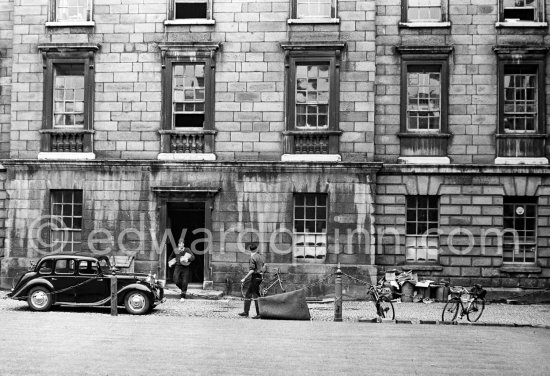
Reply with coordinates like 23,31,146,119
11,0,375,161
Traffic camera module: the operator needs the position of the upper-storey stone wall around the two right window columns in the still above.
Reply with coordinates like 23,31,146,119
375,0,550,164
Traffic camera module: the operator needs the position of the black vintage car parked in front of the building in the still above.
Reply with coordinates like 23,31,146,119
8,253,164,315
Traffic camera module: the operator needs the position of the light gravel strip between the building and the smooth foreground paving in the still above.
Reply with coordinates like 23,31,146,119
0,291,550,326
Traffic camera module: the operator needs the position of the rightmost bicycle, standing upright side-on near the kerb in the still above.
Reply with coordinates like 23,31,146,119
441,284,487,322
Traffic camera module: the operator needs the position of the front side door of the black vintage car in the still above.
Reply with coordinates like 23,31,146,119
76,260,110,304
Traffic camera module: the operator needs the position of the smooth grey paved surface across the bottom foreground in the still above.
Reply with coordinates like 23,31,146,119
0,309,550,376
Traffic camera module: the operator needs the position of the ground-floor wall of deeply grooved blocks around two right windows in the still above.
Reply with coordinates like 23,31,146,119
376,168,550,287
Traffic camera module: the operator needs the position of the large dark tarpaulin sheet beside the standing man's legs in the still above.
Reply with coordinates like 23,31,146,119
258,289,311,320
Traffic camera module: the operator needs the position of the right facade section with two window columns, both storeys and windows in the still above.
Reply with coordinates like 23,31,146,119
375,0,550,288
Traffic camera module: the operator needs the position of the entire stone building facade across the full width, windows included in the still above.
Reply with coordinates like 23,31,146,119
0,0,550,294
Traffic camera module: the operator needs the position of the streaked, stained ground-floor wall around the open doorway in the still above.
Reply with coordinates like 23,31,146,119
1,162,376,289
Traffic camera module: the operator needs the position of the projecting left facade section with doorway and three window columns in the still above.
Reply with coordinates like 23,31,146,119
2,0,380,289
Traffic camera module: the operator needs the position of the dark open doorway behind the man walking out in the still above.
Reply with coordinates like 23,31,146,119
166,202,205,284
